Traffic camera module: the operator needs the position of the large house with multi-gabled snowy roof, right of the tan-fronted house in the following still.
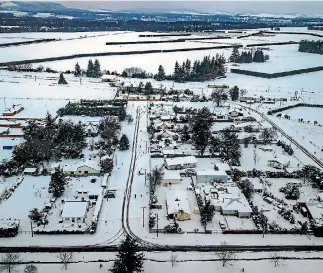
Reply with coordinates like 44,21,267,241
210,187,252,218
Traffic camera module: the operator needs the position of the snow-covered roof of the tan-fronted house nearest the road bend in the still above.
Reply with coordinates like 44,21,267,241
166,190,191,214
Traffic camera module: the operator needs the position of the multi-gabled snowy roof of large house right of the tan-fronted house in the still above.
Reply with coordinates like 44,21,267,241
211,187,252,213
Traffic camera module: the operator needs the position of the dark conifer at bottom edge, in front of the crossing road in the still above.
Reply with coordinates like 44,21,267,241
109,235,144,273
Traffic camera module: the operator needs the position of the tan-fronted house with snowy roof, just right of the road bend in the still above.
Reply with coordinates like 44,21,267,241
166,190,192,221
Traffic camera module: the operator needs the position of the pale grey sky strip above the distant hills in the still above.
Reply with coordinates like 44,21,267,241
55,0,323,14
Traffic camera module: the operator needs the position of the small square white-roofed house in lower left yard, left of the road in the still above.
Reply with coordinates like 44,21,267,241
61,201,88,223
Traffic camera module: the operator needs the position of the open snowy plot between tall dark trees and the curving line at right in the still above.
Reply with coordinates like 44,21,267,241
240,144,303,171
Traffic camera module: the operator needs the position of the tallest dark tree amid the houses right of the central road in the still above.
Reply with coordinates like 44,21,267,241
190,107,213,155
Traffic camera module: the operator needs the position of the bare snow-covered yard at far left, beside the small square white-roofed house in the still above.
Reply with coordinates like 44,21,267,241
0,176,51,231
